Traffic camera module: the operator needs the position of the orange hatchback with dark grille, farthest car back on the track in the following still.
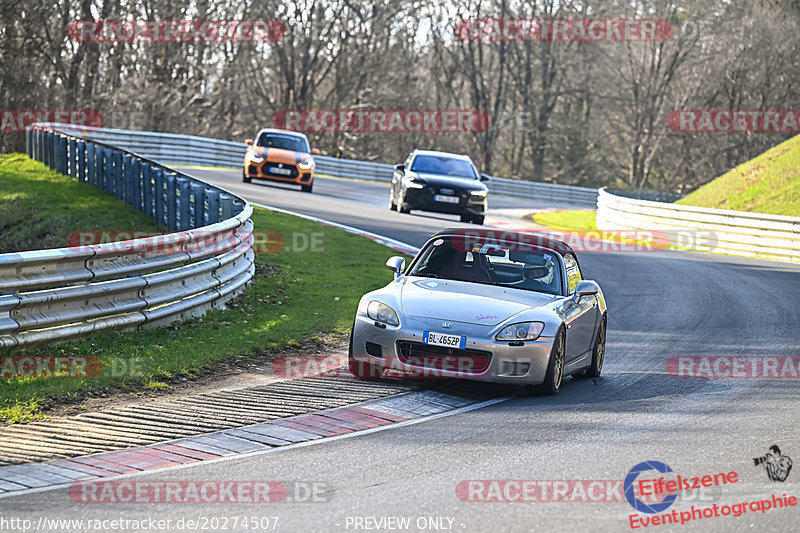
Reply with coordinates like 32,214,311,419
242,128,319,192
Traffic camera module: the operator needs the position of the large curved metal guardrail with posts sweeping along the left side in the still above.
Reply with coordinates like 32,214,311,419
0,124,255,348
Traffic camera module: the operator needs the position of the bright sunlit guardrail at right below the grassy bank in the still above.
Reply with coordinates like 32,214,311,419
597,188,800,262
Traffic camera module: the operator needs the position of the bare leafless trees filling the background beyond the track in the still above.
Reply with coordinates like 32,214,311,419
0,0,800,192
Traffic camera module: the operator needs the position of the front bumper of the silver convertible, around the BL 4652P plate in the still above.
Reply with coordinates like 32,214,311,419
352,313,553,385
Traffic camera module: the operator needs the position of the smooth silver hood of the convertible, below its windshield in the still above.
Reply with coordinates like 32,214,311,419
400,276,554,326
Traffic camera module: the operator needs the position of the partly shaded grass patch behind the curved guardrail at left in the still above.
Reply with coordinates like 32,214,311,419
0,154,161,253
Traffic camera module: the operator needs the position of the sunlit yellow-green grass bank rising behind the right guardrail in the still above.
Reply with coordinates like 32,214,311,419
677,135,800,216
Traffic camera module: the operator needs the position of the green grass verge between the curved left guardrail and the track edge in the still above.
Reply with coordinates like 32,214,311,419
0,155,406,422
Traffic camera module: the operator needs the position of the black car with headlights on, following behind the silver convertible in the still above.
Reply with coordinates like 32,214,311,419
389,150,489,224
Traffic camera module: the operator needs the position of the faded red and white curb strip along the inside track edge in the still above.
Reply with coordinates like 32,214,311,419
0,391,511,499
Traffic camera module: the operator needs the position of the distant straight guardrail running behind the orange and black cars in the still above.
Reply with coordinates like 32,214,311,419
70,128,597,209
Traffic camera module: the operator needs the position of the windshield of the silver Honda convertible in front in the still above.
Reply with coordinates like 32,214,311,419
407,237,561,295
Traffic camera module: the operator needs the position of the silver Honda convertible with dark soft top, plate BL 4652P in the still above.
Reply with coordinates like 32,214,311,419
349,229,607,394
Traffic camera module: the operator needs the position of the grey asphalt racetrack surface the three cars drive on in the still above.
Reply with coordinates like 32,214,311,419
0,170,800,532
